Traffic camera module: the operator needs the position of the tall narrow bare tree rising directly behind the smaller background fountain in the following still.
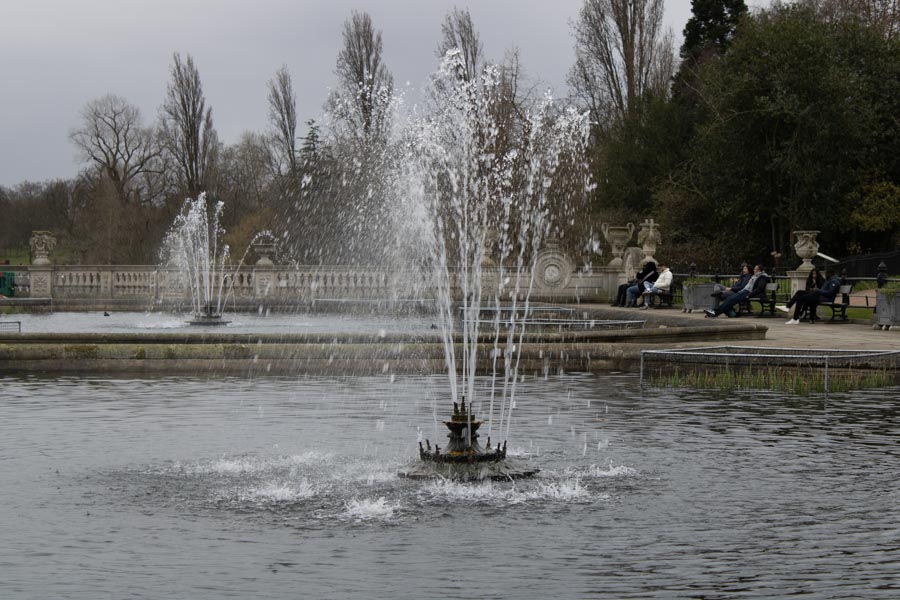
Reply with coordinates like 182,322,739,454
160,52,219,196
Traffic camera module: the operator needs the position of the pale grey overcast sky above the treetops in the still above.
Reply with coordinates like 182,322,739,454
0,0,768,186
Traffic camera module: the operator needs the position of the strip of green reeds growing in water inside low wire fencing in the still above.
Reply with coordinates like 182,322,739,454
650,367,896,396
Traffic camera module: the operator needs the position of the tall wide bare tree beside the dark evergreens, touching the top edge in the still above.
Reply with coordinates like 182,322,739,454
569,0,674,126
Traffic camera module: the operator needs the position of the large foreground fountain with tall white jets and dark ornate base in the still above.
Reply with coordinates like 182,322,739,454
395,50,587,480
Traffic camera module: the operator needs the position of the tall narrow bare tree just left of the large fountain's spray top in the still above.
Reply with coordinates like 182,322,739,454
328,11,394,144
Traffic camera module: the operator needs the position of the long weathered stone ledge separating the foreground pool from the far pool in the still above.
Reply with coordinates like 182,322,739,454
0,311,767,374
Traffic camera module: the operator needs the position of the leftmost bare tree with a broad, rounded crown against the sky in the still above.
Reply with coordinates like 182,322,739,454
69,94,160,204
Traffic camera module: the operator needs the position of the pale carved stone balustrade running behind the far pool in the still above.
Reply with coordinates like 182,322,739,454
5,259,618,309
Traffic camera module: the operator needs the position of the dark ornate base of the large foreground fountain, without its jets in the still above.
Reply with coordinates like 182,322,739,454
400,396,539,481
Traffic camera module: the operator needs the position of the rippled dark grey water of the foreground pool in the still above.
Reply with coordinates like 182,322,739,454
0,374,900,599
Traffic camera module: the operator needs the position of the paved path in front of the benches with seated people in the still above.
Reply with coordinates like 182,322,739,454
580,305,900,350
